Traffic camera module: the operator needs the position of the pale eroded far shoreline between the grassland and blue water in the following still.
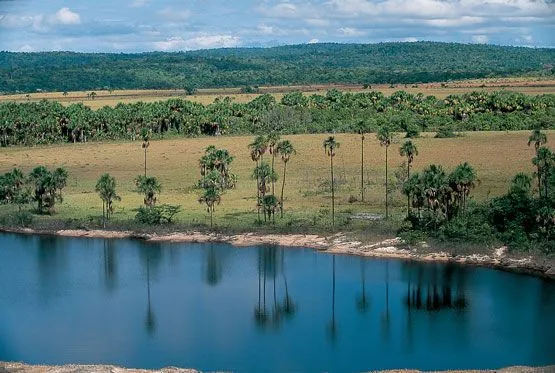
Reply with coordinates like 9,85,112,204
0,227,555,280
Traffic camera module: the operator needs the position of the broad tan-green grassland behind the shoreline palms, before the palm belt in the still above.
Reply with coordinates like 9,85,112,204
0,131,555,231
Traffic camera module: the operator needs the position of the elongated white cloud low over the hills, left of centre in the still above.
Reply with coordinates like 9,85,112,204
154,35,241,51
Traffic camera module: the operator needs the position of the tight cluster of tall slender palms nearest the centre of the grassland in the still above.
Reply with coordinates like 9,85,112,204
249,132,296,222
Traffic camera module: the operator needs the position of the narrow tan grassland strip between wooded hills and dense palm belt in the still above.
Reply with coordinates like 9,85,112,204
0,78,555,109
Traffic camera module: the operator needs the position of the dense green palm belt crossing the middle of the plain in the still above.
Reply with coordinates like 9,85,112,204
0,89,555,146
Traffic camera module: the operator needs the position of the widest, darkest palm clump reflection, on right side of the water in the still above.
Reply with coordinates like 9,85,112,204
405,265,468,312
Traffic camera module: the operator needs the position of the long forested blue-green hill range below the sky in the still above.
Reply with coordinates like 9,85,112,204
0,42,555,93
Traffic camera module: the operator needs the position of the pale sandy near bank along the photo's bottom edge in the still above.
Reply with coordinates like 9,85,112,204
0,362,555,373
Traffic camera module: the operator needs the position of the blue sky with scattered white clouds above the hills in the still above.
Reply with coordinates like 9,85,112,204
0,0,555,52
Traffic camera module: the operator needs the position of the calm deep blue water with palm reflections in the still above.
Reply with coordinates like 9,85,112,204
0,234,555,372
